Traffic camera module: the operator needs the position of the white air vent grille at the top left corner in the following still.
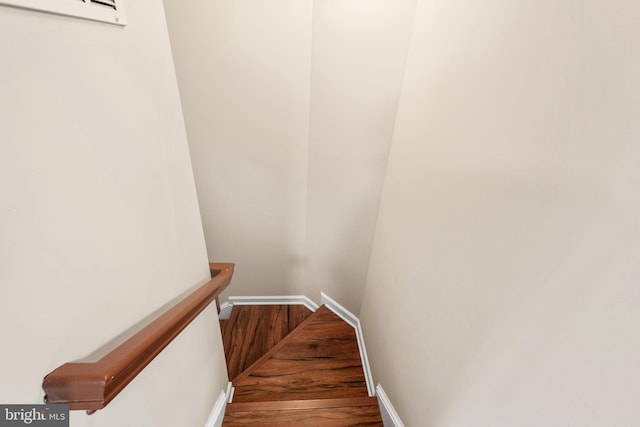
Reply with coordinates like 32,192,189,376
0,0,127,25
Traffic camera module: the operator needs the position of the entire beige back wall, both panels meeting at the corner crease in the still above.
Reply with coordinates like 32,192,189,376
165,0,415,312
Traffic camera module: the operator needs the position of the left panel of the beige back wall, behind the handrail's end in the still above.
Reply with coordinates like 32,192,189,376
165,0,312,295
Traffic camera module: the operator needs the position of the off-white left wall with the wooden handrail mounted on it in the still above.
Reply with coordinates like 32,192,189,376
0,0,227,427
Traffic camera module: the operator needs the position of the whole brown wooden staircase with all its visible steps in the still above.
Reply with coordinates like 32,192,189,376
220,305,382,427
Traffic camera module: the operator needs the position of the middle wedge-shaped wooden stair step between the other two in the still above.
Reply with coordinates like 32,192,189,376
233,306,368,403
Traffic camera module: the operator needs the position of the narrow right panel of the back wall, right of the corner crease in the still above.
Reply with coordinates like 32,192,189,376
305,0,415,313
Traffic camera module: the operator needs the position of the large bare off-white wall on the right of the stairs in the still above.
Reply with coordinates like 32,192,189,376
361,0,640,427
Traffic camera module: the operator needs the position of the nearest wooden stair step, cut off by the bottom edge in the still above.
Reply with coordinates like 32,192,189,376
223,397,383,427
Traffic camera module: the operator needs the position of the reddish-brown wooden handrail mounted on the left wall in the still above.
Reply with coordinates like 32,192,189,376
42,263,234,412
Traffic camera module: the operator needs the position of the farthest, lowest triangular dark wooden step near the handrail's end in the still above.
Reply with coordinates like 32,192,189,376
220,305,312,380
